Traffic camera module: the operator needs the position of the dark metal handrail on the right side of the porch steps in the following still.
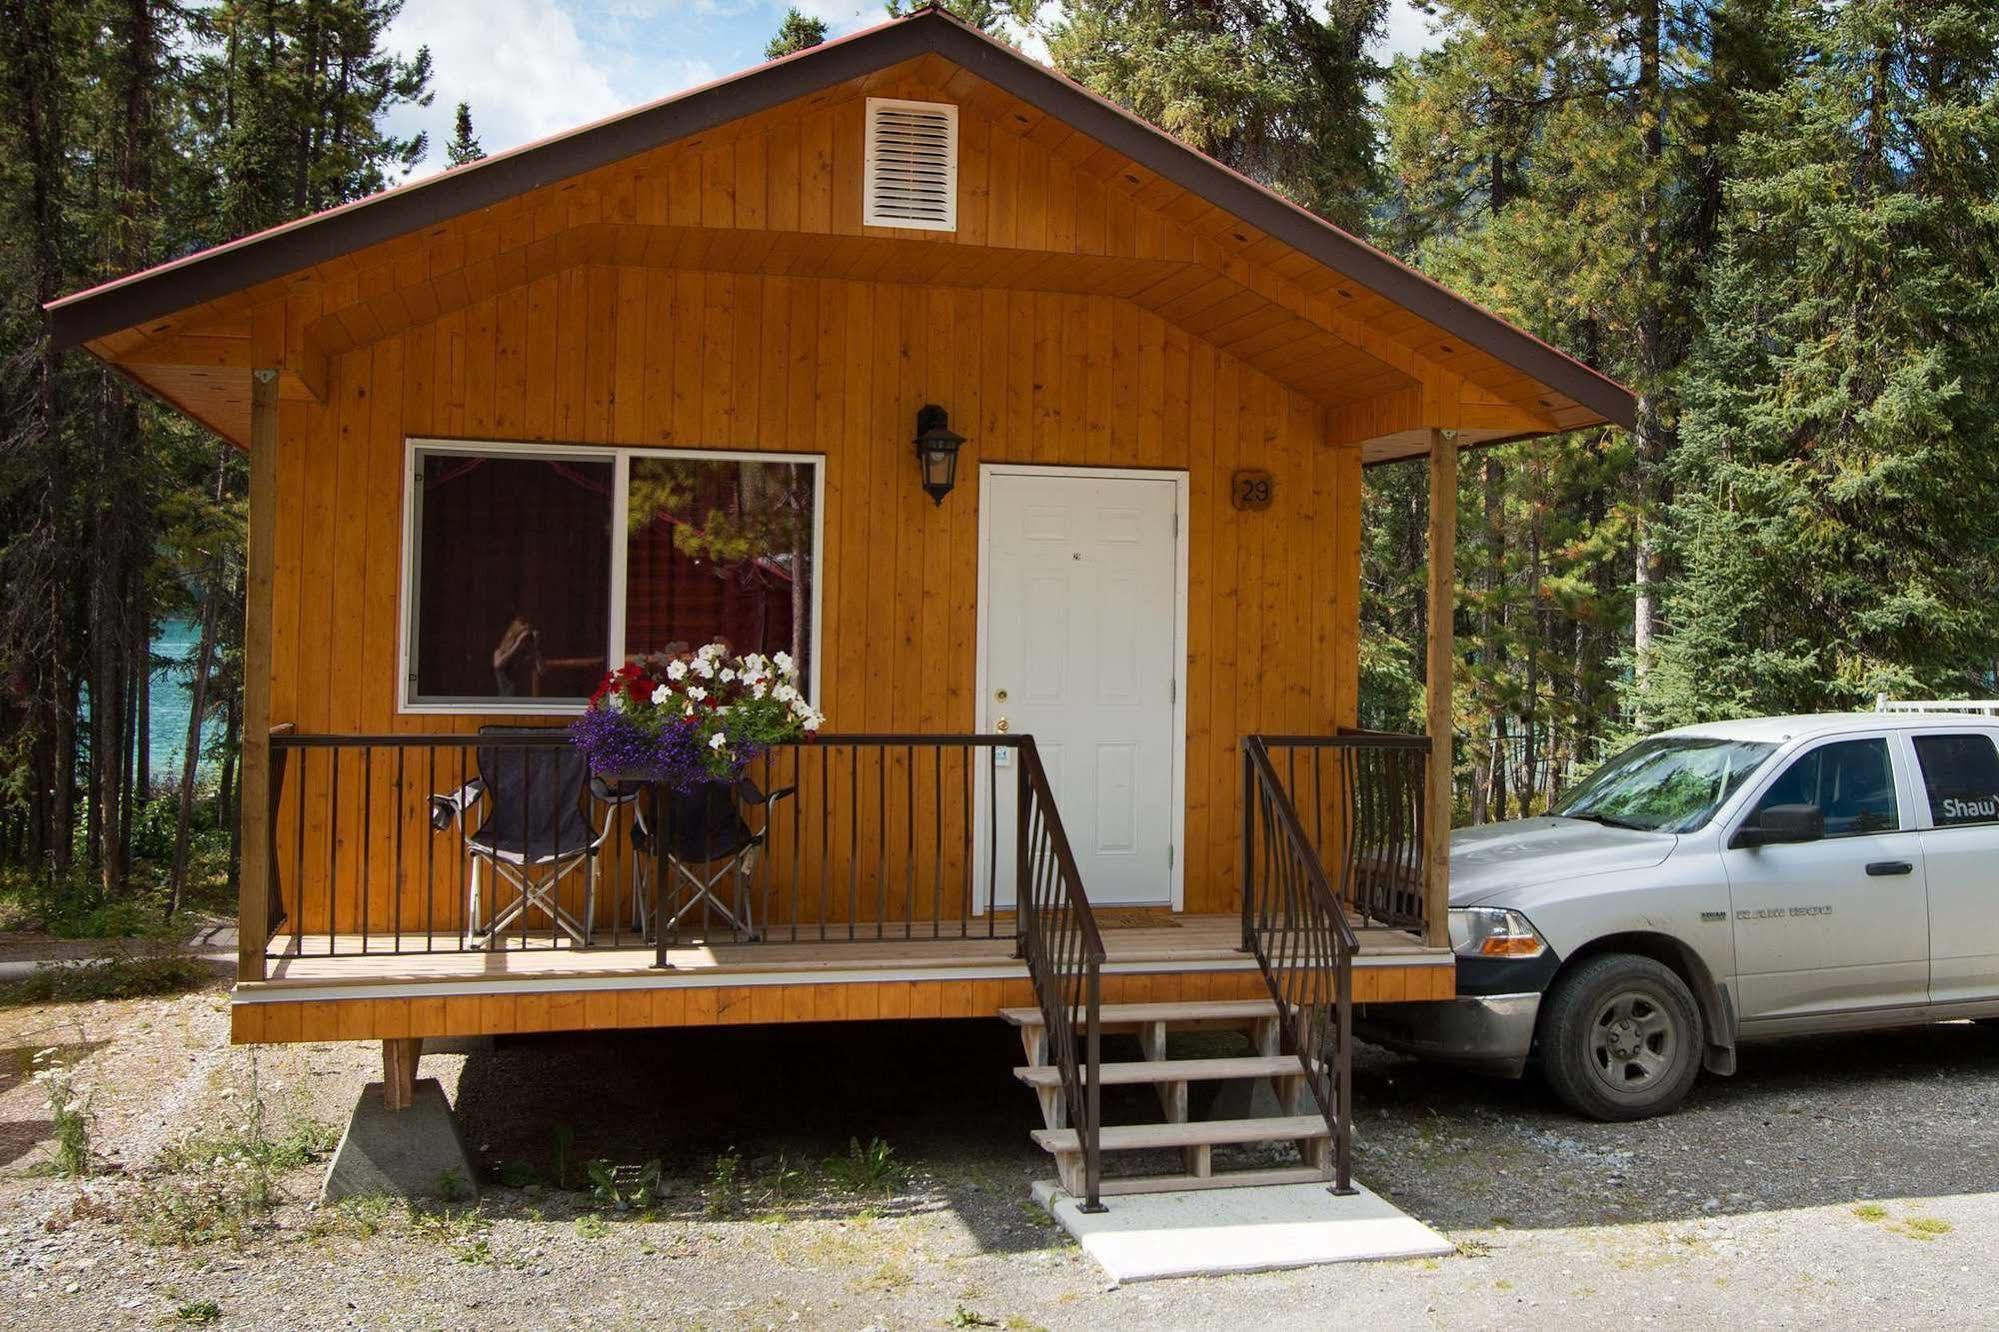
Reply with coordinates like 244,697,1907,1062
1243,736,1359,1194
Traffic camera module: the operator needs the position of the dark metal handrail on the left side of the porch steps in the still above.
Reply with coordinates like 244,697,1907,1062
1013,736,1103,1212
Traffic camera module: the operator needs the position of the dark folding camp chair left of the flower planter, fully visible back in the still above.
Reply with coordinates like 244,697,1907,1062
430,726,632,948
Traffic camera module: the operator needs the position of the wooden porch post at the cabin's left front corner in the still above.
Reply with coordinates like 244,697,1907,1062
236,368,278,980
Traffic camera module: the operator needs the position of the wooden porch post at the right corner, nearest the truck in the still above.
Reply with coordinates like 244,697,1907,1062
1423,430,1457,948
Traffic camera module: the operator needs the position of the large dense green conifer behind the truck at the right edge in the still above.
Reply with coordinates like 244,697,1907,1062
1659,0,1999,720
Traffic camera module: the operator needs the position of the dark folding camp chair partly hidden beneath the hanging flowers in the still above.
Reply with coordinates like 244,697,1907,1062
632,778,798,940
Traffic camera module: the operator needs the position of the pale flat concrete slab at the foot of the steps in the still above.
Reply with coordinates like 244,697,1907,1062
1033,1180,1453,1282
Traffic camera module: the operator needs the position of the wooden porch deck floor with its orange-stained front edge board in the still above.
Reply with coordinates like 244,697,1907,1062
234,916,1455,1042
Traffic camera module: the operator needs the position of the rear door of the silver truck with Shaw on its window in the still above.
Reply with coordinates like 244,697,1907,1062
1909,730,1999,1004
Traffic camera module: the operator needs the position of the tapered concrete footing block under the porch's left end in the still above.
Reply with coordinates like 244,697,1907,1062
320,1078,480,1202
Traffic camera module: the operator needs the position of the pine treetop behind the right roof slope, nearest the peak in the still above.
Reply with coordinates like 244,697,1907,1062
1047,0,1387,230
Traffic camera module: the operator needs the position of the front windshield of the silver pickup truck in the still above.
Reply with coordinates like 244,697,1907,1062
1553,736,1777,832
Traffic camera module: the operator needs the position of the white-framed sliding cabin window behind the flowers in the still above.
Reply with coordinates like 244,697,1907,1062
402,440,822,712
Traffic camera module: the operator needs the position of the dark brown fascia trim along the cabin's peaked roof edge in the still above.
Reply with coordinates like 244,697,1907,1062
48,8,1635,428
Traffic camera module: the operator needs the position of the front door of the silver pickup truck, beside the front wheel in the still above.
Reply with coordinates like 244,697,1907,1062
1721,734,1929,1022
